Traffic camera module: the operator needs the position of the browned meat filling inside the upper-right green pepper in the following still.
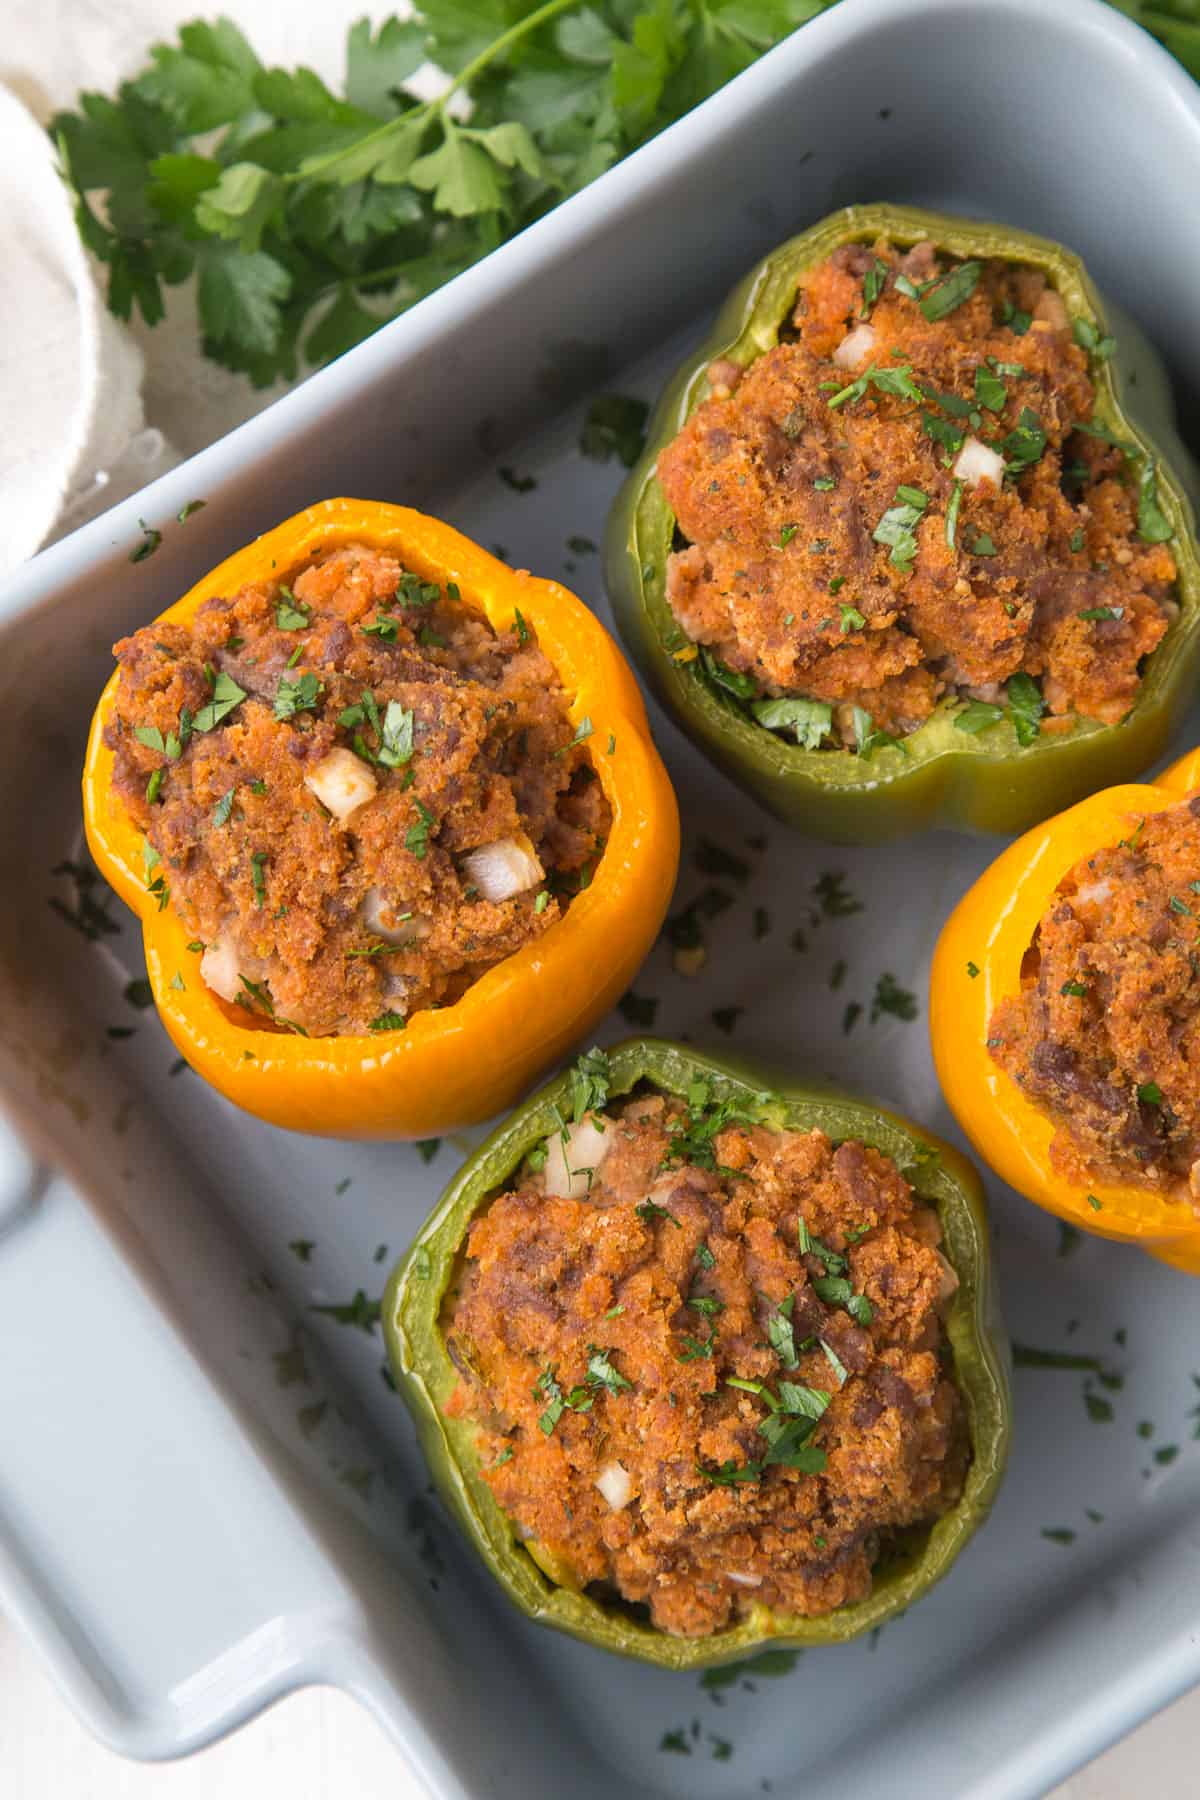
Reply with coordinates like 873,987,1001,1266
658,243,1175,749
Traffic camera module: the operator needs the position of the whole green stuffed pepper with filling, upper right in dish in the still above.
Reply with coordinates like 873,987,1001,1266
606,205,1200,842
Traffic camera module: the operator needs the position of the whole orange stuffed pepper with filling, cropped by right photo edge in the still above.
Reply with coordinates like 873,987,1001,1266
930,751,1200,1274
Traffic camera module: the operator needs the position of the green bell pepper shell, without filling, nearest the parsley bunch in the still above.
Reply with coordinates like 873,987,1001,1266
604,205,1200,844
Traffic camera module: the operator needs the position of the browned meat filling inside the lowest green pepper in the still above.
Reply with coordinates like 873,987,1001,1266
444,1096,966,1636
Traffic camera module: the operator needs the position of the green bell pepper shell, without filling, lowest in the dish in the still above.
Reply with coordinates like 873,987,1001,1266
381,1039,1009,1669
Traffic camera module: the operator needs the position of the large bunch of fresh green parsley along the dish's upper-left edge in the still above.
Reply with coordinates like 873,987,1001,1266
50,0,831,385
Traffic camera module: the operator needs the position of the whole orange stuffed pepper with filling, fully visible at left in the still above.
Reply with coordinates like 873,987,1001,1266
83,500,678,1138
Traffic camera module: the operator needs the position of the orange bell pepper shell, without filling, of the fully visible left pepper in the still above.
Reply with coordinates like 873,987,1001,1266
83,500,678,1138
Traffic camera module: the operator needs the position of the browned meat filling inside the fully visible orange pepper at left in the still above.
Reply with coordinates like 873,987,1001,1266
106,547,610,1035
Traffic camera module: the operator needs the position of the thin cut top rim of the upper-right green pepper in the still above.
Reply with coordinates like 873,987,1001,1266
606,205,1200,826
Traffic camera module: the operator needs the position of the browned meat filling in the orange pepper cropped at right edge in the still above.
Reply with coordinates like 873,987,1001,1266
988,797,1200,1210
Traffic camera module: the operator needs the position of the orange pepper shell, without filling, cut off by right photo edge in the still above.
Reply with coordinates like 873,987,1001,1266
930,751,1200,1274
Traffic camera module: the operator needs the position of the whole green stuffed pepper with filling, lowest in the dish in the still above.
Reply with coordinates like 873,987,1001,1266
383,1039,1009,1669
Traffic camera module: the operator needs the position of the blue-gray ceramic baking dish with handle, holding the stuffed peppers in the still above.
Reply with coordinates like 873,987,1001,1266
0,0,1200,1800
